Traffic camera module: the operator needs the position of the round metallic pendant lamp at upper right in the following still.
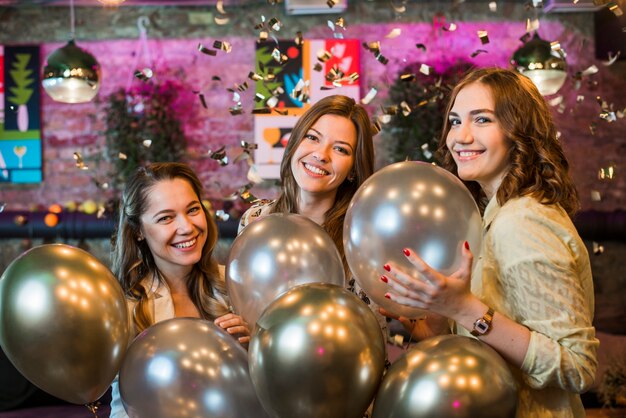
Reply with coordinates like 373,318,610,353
511,32,567,96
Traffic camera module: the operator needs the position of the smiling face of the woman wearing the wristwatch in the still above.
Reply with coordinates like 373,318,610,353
446,82,511,198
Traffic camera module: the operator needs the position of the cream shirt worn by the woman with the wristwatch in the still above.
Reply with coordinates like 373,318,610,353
457,197,599,418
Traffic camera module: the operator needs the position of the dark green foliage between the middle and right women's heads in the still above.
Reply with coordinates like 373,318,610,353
381,63,471,164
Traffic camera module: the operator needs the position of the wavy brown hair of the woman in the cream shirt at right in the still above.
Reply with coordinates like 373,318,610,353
437,68,579,217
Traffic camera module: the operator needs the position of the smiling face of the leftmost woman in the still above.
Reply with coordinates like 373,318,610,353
141,178,207,275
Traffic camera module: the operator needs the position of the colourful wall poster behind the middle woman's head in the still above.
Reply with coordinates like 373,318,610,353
254,39,361,179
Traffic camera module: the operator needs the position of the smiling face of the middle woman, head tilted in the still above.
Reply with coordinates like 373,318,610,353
291,115,357,198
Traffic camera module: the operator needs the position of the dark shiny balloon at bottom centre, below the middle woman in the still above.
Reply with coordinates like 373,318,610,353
248,283,385,418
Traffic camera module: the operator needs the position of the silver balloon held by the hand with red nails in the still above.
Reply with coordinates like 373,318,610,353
343,161,482,318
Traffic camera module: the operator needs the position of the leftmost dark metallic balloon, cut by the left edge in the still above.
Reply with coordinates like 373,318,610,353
0,244,129,404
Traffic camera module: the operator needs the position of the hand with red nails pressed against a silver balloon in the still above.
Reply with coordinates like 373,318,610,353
383,242,474,318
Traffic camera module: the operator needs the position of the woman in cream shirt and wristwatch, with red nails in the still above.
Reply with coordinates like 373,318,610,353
381,68,598,417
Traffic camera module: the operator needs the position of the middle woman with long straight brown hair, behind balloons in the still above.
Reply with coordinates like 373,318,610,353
239,95,387,338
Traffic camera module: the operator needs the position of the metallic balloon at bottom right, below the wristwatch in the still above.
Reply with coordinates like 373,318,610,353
373,335,517,418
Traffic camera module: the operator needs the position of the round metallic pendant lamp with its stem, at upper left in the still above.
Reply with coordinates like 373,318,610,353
41,0,100,103
